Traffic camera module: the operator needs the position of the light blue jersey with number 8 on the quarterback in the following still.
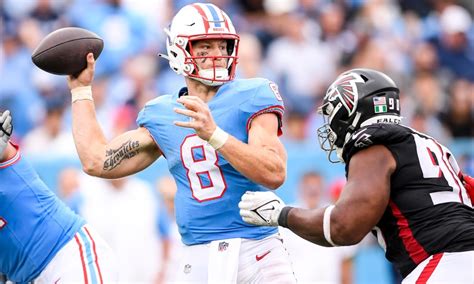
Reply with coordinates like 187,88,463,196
137,79,284,245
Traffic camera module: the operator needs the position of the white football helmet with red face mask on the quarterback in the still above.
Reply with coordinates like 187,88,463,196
161,3,239,86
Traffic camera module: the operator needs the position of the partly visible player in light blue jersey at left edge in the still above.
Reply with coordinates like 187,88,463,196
0,110,116,284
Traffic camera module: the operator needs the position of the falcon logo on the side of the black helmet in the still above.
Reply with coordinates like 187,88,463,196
324,73,364,115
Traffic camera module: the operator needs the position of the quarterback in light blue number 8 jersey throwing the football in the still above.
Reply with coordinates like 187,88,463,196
68,3,295,283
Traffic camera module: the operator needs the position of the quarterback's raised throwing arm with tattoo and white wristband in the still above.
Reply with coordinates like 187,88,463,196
68,53,161,178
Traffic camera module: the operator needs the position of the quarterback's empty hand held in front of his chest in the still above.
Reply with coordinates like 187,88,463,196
174,96,217,141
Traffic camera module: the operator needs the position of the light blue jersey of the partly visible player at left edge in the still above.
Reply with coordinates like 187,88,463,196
0,148,85,283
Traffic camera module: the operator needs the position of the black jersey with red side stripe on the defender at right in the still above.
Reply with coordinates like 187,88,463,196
343,124,474,277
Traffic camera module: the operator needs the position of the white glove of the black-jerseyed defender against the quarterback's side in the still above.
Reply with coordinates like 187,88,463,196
239,191,285,226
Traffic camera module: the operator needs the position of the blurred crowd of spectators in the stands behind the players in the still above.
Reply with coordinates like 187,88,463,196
0,0,474,283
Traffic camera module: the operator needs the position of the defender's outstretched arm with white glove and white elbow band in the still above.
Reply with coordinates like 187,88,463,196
243,145,396,246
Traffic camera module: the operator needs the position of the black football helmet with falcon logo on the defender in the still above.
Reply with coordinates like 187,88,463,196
318,69,401,162
